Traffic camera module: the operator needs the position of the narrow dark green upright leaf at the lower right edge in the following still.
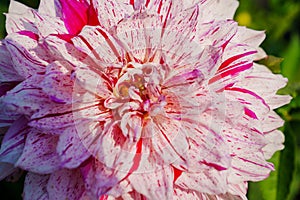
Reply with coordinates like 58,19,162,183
276,122,296,200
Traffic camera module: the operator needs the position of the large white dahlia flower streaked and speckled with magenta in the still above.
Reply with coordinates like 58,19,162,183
0,0,290,200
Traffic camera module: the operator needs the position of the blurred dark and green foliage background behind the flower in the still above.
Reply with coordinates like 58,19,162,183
0,0,300,200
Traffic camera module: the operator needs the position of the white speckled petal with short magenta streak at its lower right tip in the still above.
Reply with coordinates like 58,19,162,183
175,121,231,172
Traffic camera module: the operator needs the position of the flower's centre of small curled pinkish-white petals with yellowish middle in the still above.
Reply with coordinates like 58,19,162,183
104,62,166,140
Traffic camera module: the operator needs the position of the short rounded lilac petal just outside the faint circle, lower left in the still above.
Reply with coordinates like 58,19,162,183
56,127,91,168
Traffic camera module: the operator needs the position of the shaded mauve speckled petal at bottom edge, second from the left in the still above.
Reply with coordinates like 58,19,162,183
47,169,85,200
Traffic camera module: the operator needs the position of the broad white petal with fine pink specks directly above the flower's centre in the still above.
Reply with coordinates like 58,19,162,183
114,13,162,63
